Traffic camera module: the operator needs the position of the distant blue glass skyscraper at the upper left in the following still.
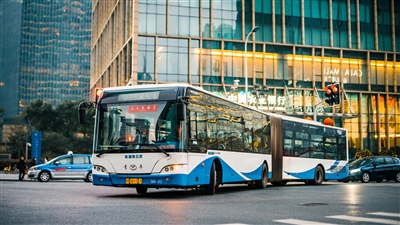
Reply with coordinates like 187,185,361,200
0,0,92,117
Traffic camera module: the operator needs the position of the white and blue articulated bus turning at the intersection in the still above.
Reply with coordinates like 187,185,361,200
78,84,348,195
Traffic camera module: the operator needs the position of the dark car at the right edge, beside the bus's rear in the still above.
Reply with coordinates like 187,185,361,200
349,156,400,183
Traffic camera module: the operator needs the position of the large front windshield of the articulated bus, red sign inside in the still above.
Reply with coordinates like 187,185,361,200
95,101,179,153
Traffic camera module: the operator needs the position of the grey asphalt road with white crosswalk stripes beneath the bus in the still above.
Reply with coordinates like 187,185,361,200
0,177,400,225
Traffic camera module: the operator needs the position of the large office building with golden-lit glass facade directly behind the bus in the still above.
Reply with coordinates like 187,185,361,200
90,0,400,155
